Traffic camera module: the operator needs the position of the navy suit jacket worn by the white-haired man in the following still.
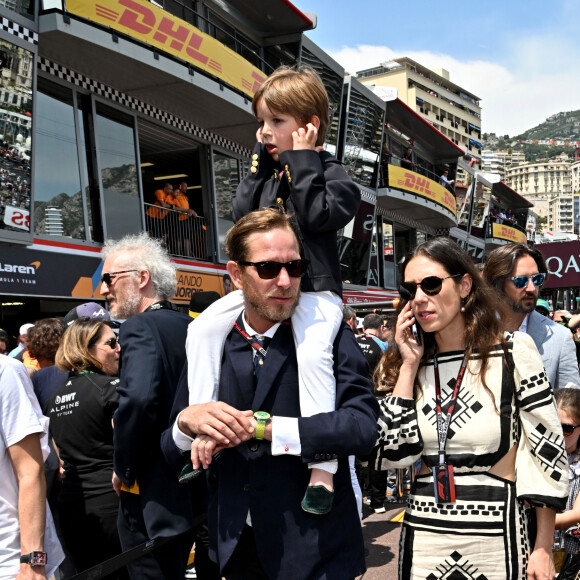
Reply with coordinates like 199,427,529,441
113,309,193,538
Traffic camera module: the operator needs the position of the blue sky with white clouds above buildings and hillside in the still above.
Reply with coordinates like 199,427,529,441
293,0,580,136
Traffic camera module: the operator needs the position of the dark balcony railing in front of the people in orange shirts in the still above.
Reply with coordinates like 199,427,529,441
144,203,208,260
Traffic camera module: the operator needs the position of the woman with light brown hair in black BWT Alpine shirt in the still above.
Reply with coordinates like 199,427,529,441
44,317,128,580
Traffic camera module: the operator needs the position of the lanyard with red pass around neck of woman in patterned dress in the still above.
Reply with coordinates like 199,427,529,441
433,349,469,503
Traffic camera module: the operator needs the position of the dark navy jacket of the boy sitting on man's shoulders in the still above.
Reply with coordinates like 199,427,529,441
233,143,360,296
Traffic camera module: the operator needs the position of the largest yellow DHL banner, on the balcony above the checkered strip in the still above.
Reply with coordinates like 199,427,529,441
66,0,266,97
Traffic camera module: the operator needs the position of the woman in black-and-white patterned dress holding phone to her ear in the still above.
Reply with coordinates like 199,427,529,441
375,238,568,580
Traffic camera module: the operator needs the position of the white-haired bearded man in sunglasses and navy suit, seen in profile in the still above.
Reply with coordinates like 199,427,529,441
100,234,193,580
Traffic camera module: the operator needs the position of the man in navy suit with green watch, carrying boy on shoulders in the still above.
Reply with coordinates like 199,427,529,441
162,209,378,580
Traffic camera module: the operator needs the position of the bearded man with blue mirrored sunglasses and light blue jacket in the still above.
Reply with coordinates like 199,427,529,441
483,244,580,389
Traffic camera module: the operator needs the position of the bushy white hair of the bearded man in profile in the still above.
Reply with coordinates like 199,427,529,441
101,232,177,300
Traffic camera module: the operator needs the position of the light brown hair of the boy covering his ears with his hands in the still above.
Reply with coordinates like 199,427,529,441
252,66,329,145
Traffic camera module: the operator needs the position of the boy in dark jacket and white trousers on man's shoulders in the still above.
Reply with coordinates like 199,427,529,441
187,67,360,514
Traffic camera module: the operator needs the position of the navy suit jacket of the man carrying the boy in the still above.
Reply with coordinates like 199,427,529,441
162,318,378,580
